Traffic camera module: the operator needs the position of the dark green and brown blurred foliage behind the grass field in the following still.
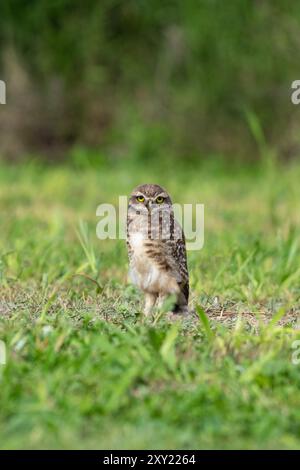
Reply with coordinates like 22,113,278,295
0,0,300,163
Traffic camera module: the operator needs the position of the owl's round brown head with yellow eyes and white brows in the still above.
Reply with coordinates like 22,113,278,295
129,184,172,212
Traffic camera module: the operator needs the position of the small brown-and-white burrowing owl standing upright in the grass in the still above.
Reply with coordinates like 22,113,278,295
127,184,189,315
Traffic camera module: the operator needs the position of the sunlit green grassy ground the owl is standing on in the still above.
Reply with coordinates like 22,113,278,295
0,159,300,448
